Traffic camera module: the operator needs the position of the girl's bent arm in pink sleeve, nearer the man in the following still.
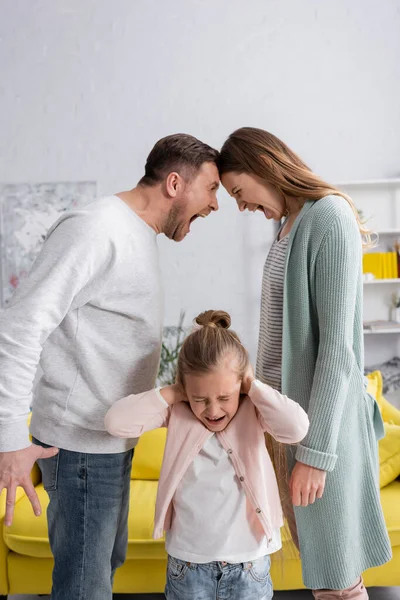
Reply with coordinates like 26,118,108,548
104,385,183,438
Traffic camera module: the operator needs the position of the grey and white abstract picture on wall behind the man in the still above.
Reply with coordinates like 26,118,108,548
0,181,96,307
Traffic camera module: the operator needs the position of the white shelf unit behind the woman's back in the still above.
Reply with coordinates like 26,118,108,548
337,177,400,366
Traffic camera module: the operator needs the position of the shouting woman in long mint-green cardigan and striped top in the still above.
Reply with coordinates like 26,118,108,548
219,127,391,600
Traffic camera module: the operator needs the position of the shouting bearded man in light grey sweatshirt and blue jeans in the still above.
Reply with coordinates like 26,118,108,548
0,134,219,600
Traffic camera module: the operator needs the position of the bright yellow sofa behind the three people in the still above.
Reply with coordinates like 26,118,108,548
0,380,400,596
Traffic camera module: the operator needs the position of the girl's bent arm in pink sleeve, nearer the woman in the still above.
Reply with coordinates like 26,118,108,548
242,371,309,444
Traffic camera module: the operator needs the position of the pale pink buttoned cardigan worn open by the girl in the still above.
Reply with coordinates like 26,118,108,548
105,381,309,540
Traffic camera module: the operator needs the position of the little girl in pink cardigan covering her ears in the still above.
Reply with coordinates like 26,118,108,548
105,310,308,600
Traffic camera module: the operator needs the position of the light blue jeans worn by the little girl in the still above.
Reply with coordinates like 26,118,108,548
165,556,273,600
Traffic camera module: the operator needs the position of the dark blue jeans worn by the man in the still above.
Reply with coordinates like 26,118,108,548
33,439,133,600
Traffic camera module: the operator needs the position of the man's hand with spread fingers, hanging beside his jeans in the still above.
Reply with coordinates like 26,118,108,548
0,444,58,527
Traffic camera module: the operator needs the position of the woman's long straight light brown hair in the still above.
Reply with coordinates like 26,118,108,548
218,127,373,247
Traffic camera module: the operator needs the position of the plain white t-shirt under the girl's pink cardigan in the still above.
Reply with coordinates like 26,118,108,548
166,434,282,563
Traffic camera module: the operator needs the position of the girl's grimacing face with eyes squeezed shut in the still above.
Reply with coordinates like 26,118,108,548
185,356,242,432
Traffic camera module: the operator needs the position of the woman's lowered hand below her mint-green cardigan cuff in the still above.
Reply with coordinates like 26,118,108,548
289,462,326,506
